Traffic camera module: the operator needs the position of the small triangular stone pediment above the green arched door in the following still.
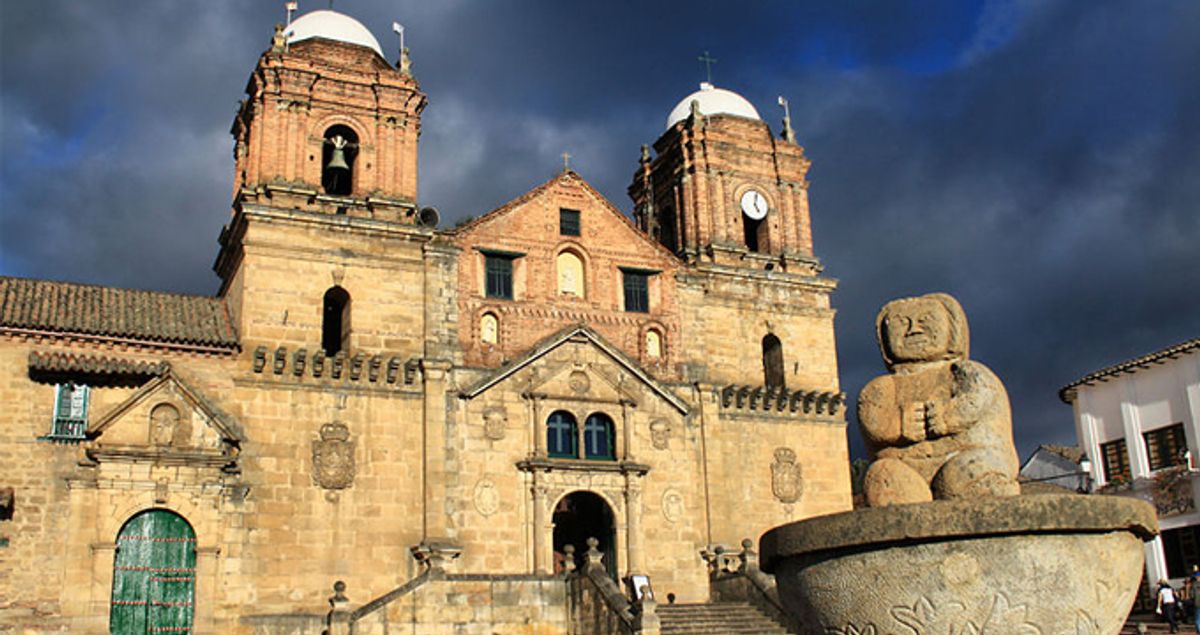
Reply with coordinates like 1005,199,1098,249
88,371,244,462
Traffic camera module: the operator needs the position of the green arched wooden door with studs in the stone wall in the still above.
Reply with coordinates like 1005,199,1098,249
108,510,196,635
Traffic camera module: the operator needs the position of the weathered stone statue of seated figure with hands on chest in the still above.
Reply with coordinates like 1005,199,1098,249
858,293,1020,507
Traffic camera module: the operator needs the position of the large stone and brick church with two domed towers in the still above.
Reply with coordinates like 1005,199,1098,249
0,11,851,634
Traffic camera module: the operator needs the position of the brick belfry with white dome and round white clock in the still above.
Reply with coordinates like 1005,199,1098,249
629,82,821,275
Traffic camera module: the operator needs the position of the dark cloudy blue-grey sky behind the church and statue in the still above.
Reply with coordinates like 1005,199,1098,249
0,0,1200,456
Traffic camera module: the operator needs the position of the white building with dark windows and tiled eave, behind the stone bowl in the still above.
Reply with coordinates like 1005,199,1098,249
1058,337,1200,581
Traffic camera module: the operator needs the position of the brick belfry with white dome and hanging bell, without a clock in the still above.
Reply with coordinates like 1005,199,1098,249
230,11,428,223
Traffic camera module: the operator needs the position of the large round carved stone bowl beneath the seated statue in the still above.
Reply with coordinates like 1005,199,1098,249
761,495,1158,635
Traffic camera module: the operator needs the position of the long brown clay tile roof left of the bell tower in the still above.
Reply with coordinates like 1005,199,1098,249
0,276,238,349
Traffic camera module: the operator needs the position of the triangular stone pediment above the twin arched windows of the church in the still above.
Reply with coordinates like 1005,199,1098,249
461,325,688,415
